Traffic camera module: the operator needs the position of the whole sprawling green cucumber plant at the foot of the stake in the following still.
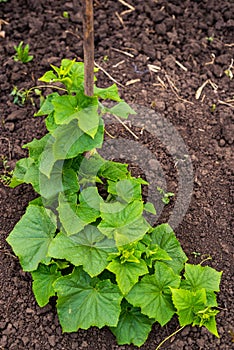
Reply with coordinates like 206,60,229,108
7,59,222,346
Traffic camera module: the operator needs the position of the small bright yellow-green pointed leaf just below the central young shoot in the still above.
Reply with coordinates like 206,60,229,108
107,259,148,295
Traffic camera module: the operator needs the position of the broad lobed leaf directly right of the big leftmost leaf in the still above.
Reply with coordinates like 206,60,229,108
49,225,114,277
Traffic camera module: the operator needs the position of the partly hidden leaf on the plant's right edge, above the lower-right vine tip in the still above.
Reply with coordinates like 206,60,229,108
152,224,187,273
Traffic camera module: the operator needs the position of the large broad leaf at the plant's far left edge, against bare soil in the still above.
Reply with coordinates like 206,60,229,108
7,205,56,271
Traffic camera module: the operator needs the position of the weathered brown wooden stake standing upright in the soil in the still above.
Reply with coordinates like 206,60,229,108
83,0,94,96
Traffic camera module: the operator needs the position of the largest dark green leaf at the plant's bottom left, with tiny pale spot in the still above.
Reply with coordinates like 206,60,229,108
54,268,123,332
